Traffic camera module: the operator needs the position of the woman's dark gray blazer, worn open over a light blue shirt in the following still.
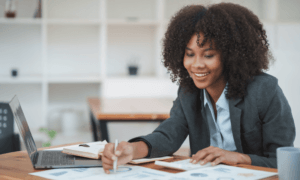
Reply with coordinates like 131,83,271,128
129,73,295,168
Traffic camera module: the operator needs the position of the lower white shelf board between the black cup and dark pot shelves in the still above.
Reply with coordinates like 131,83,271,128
47,75,102,84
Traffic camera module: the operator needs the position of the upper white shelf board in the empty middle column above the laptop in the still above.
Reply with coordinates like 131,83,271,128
46,19,101,25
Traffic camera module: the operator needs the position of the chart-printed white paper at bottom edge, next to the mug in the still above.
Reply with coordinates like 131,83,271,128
170,165,277,180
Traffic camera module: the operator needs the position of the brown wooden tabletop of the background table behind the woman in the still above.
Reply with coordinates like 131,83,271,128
88,98,173,120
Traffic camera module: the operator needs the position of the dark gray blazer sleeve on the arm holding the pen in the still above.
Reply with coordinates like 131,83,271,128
129,87,189,158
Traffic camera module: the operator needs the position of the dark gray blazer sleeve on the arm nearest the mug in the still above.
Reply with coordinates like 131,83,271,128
249,83,295,168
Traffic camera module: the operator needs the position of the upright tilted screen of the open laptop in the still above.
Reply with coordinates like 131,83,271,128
9,96,37,164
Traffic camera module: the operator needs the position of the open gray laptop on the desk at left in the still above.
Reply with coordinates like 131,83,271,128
9,96,102,169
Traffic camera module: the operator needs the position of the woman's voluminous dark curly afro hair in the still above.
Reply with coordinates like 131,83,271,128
162,3,274,98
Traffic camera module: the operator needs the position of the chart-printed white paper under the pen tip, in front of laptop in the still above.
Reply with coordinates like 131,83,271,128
30,165,172,180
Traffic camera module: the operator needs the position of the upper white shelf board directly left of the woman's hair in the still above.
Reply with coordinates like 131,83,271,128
107,19,159,25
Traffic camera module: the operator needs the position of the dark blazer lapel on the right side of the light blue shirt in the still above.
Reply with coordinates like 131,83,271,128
229,98,243,153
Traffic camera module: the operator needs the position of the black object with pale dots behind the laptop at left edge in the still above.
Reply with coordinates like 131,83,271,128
0,103,21,154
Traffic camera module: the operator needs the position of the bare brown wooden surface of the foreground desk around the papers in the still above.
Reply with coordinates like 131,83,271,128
0,142,278,180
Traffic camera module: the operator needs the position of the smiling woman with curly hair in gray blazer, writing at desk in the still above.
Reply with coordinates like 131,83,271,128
102,3,295,173
